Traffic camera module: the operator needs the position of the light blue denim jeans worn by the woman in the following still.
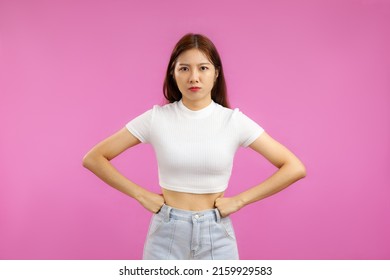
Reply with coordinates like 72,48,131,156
143,204,238,260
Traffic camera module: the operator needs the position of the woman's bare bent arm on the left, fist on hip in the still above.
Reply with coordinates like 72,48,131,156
83,128,164,213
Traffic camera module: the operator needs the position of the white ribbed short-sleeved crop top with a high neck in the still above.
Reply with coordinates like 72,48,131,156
126,100,264,194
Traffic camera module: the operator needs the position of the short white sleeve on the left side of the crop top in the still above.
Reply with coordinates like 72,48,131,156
126,109,153,143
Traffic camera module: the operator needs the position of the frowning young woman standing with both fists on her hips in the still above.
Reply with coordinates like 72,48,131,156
83,34,306,259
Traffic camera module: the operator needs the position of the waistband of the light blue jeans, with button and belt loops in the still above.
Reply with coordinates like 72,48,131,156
157,204,221,223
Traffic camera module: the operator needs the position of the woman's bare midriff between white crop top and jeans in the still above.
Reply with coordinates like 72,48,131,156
162,188,223,211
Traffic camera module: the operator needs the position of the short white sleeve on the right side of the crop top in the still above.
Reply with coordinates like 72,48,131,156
234,109,264,148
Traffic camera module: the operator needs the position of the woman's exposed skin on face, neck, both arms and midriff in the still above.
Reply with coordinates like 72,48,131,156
83,49,306,217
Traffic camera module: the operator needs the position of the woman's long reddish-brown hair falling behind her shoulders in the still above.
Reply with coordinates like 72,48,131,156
163,33,229,108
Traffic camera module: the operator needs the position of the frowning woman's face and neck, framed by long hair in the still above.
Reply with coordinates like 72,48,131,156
174,49,218,110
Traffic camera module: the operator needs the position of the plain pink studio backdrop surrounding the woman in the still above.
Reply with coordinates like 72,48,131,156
0,0,390,259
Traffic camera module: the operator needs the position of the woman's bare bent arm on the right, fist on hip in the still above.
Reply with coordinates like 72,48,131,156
215,132,306,217
